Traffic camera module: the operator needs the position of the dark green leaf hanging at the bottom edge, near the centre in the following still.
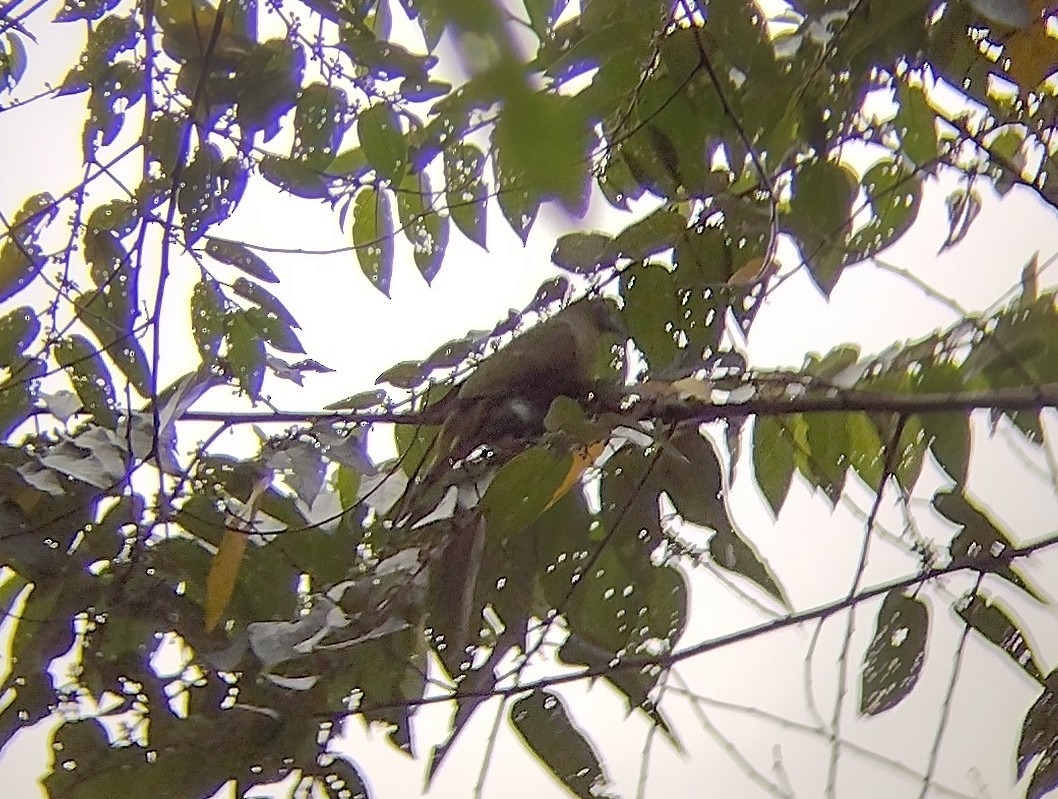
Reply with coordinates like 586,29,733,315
510,690,610,799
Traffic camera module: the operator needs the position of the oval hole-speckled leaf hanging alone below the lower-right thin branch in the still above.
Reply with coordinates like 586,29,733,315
860,591,929,715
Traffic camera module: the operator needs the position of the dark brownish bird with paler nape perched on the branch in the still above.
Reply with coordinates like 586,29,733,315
414,297,625,474
